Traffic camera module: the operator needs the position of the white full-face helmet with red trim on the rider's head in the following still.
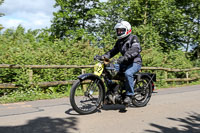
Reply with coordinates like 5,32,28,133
114,21,131,39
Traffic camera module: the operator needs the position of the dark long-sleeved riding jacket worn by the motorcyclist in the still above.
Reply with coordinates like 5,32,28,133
103,34,142,65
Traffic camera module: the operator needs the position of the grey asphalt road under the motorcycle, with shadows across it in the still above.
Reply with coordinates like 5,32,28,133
0,85,200,133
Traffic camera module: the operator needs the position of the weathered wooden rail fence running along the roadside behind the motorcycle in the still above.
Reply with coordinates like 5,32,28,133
0,64,200,89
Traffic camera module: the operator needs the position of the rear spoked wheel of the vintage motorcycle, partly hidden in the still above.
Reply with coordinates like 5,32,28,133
133,78,152,107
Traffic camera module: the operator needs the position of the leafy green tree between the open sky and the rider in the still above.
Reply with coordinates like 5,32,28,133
51,0,101,39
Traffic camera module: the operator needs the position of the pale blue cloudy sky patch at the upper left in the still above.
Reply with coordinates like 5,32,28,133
0,0,56,29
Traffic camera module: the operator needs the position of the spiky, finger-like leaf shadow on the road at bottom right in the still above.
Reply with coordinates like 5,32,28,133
146,113,200,133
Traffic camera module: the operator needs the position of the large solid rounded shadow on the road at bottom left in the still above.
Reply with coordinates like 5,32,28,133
0,117,78,133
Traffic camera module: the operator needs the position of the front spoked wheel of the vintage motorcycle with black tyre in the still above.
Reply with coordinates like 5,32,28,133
70,78,103,115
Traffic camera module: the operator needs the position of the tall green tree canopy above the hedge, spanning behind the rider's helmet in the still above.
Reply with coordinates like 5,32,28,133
52,0,200,55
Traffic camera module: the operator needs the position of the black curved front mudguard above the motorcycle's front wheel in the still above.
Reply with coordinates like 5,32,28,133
78,73,105,100
